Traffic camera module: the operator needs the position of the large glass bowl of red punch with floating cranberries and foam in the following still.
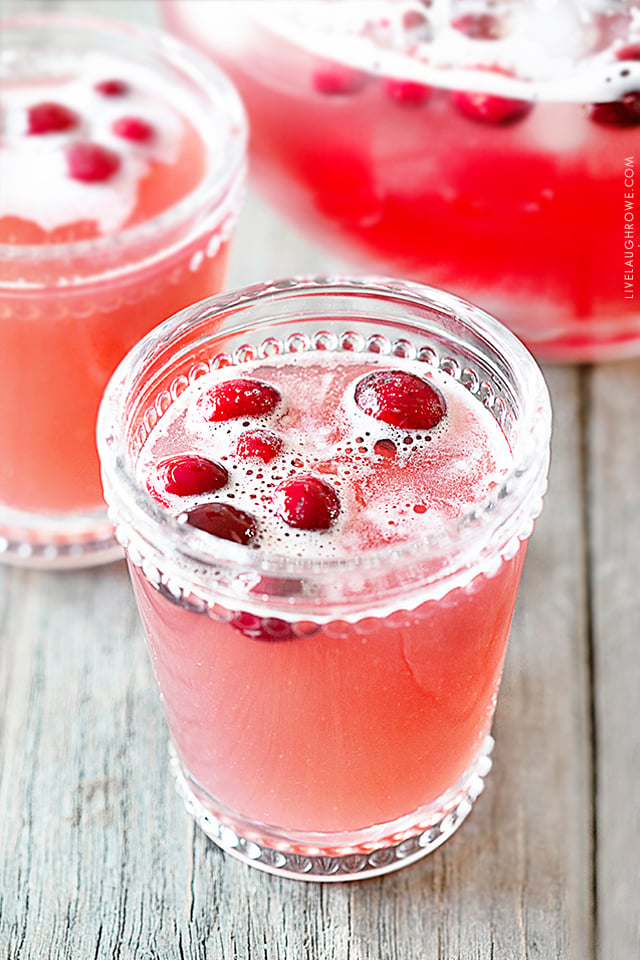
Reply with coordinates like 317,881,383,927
163,0,640,361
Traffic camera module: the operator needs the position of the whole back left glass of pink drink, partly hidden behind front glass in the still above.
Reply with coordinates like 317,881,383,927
0,15,246,566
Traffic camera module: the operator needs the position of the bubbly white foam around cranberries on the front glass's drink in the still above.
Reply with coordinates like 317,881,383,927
138,352,512,558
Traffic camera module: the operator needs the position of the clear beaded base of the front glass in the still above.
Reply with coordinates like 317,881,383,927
169,737,494,882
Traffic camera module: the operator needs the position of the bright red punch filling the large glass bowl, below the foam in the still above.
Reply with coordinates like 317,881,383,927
165,0,640,360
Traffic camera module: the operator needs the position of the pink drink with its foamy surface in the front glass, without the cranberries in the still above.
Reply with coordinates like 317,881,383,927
131,355,525,851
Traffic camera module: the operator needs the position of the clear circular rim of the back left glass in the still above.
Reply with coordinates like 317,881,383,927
0,11,249,263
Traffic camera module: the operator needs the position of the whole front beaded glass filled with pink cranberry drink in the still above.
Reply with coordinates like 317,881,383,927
98,278,550,880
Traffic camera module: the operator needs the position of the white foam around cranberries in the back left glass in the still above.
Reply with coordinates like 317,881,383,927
0,55,184,234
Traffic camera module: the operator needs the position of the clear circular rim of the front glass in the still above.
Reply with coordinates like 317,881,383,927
97,275,551,579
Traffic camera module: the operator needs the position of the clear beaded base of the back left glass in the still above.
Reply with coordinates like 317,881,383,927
0,505,124,570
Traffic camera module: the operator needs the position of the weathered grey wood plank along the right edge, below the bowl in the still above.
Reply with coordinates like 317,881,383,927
587,360,640,960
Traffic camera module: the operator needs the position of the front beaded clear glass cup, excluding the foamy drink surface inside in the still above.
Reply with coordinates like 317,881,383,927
98,278,550,880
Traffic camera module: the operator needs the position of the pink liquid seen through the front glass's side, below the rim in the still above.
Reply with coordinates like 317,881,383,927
131,547,524,844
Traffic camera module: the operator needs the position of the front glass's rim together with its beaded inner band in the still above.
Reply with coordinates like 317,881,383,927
98,275,551,588
